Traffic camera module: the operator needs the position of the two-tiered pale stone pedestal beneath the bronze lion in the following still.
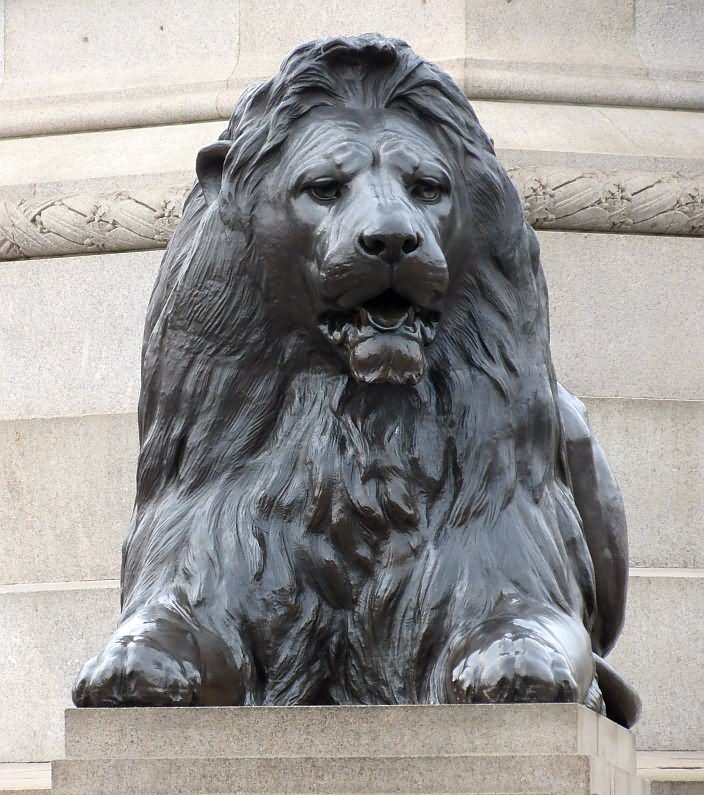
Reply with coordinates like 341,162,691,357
52,704,645,795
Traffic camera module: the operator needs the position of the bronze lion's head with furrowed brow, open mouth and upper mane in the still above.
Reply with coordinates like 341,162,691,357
148,35,531,394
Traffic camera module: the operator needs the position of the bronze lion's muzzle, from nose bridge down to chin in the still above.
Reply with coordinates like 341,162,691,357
318,175,449,385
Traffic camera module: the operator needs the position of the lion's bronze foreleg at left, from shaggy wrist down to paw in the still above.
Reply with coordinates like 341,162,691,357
73,594,253,707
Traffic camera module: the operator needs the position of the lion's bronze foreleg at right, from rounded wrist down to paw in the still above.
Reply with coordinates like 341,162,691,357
438,599,596,706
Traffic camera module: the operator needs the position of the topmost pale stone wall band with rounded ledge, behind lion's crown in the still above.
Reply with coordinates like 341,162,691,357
0,0,704,136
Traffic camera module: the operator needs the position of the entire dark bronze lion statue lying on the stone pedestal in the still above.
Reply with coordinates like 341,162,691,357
73,34,638,725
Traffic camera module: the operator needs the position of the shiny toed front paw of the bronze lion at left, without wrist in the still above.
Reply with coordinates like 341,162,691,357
73,635,201,707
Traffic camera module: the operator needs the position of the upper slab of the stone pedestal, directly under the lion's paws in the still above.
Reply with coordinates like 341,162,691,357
66,704,636,771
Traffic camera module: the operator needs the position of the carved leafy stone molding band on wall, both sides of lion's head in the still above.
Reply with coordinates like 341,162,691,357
0,166,704,260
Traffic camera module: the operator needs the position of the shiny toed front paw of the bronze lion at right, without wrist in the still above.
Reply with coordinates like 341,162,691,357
451,632,579,704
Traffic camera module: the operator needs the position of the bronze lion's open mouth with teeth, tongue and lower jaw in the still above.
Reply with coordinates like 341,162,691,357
319,290,440,384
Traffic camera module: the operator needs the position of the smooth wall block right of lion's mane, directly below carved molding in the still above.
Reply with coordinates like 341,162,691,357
539,232,704,400
